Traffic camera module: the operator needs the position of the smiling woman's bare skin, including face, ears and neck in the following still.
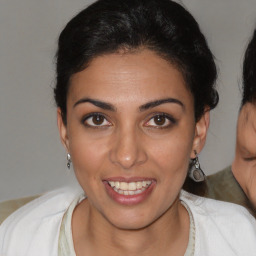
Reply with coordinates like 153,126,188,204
58,50,209,256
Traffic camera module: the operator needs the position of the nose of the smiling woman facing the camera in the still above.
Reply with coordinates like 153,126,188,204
110,125,147,170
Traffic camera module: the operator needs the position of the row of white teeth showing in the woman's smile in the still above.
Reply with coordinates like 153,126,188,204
108,180,152,196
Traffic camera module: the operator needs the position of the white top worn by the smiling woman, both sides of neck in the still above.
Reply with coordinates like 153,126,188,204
0,188,256,256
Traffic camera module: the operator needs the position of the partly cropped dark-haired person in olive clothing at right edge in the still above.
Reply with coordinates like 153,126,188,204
206,29,256,217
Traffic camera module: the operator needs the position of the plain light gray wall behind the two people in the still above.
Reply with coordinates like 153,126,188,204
0,0,256,200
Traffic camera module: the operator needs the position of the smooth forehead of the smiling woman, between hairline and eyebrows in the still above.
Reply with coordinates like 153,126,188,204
68,50,193,107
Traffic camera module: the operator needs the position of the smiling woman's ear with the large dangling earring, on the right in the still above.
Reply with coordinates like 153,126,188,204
190,109,210,158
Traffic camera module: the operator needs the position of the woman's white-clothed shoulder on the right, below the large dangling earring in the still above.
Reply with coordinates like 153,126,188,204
181,192,256,256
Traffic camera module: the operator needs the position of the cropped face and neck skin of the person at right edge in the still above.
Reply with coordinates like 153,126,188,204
232,103,256,208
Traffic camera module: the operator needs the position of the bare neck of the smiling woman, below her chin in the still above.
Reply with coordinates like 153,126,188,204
72,196,189,256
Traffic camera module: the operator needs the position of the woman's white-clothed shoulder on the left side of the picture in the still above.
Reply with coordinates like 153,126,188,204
0,187,81,256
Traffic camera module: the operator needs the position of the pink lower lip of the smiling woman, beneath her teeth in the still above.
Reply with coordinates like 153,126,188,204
103,181,155,205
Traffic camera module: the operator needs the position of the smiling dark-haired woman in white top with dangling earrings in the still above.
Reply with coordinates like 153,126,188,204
0,0,256,256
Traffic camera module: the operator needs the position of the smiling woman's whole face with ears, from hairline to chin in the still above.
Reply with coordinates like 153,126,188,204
58,50,207,229
